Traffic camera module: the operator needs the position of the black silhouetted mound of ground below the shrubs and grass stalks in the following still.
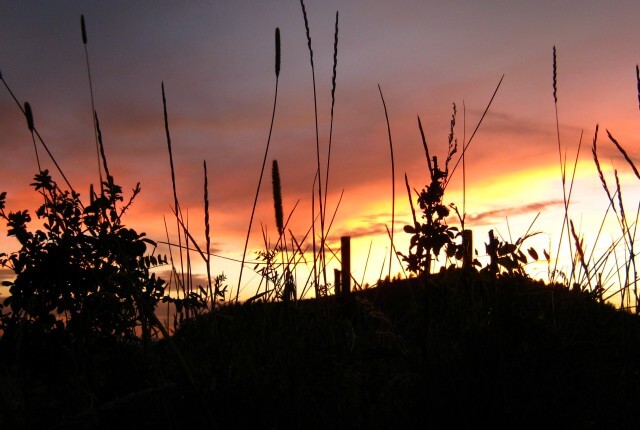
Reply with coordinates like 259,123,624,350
0,269,640,429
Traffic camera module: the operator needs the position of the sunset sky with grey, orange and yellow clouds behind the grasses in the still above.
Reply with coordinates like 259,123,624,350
0,0,640,298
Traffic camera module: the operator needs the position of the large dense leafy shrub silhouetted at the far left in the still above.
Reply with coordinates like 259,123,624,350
0,170,170,339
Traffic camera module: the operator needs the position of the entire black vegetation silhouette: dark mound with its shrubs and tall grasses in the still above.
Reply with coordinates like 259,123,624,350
0,2,640,430
